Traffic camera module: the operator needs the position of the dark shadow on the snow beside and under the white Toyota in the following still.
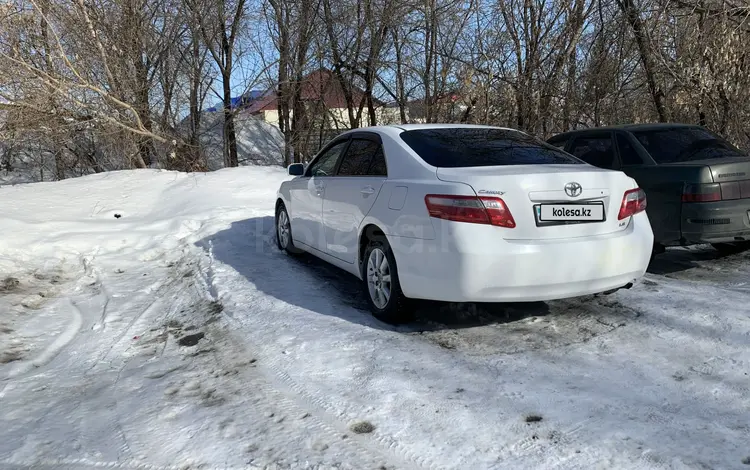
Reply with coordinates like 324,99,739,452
196,216,550,333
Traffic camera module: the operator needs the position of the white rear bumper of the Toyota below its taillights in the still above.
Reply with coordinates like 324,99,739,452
390,214,653,302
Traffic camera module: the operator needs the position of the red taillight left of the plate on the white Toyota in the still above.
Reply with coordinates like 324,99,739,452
424,194,516,228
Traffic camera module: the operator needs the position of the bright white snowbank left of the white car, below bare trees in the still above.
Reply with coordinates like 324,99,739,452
0,167,288,258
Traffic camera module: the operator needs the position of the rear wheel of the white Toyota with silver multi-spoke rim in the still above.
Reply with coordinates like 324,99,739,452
362,236,414,325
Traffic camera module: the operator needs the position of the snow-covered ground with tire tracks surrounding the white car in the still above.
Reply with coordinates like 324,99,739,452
0,167,750,469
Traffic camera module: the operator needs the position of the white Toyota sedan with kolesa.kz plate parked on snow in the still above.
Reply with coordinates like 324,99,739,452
276,124,653,323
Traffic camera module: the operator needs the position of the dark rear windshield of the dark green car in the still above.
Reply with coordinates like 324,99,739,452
633,127,745,163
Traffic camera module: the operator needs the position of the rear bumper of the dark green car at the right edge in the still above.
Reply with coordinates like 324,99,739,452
682,199,750,244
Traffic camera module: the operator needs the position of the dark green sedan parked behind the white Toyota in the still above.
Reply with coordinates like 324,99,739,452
548,124,750,253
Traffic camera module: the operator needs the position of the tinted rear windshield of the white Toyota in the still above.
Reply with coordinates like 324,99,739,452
401,128,584,168
